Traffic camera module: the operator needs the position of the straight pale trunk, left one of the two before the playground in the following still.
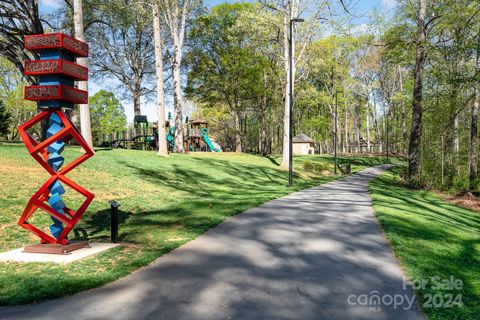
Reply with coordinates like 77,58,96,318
153,0,168,156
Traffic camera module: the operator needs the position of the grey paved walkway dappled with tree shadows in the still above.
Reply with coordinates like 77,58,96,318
0,168,423,320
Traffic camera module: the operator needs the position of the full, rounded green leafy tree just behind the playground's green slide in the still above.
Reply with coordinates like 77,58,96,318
187,3,268,152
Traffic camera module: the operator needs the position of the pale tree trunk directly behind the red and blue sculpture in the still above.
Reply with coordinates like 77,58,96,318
73,0,93,149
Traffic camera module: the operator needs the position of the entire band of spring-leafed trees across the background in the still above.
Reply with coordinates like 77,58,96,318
0,0,480,190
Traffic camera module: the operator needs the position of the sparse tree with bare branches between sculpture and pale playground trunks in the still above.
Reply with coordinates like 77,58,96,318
87,0,155,120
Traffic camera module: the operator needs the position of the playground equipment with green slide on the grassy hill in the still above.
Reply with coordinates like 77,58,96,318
100,112,221,152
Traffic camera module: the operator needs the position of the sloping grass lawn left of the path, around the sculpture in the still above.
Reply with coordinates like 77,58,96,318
0,145,385,305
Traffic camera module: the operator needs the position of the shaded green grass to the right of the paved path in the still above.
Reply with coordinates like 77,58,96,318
370,169,480,320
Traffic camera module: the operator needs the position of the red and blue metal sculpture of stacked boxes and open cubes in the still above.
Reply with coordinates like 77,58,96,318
18,33,94,245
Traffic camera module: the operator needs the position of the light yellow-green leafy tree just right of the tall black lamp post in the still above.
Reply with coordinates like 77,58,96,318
295,35,362,152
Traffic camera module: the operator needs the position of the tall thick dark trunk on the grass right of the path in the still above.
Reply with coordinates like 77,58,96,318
408,0,427,181
